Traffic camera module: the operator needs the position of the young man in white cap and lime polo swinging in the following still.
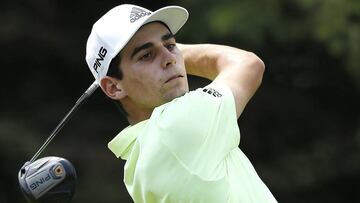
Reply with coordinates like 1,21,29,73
86,5,276,203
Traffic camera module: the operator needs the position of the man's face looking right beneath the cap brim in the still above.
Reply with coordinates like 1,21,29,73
120,22,189,109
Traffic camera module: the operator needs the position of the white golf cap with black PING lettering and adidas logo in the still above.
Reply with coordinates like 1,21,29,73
85,4,189,84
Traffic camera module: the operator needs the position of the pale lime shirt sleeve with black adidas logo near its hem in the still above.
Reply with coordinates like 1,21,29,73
157,82,240,177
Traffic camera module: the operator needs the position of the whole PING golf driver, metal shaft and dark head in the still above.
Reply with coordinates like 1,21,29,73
18,81,99,203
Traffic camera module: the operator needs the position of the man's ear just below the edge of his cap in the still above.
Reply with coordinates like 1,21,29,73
100,76,127,100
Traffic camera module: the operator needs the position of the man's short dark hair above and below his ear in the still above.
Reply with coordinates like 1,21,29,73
106,53,128,117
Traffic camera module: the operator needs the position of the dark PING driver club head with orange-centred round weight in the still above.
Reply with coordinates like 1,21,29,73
18,156,77,203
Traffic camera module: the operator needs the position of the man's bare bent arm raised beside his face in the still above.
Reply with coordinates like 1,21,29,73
177,43,265,118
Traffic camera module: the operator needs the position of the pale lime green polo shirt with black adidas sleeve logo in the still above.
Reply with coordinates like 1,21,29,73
108,83,277,203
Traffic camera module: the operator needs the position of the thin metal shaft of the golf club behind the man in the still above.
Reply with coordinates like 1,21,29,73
30,81,99,163
